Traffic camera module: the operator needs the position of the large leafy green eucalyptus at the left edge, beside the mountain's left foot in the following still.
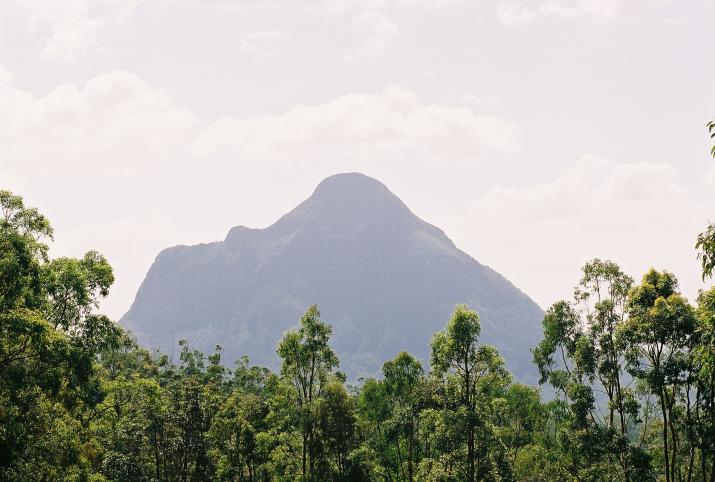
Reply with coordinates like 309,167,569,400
0,191,121,480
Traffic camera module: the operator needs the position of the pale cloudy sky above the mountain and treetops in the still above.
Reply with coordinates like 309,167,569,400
0,0,715,318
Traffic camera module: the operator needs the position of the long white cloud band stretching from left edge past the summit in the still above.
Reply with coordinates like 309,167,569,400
0,71,518,178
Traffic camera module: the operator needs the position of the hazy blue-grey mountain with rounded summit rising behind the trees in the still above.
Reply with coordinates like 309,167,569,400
120,173,543,381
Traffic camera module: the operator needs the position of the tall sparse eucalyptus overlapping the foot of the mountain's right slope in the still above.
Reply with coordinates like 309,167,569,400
533,259,649,481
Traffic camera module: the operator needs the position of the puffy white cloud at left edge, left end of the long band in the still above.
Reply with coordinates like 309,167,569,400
0,71,200,177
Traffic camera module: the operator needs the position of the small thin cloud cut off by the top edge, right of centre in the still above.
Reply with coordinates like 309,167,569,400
496,0,643,26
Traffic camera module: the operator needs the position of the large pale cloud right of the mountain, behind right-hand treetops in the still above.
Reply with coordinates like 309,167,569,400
463,156,715,307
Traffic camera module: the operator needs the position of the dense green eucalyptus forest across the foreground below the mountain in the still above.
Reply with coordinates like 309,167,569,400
0,133,715,482
